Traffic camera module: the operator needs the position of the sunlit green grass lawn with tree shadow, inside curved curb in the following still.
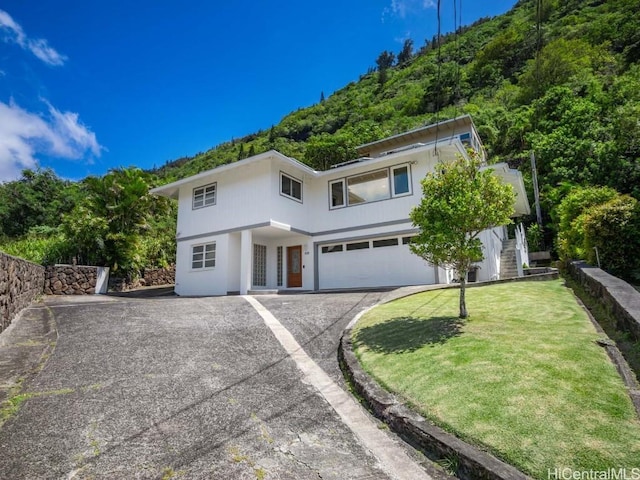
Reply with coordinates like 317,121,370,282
353,280,640,479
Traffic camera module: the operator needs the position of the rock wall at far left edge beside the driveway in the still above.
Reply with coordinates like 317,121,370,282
0,252,45,332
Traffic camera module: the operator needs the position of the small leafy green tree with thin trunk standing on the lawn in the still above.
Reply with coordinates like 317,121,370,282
409,155,515,318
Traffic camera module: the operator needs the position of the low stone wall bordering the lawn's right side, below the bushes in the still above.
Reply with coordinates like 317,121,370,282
569,262,640,340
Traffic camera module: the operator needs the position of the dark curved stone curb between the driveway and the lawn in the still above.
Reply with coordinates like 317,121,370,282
338,322,530,480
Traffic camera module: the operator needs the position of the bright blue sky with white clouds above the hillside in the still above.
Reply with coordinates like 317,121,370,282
0,0,515,182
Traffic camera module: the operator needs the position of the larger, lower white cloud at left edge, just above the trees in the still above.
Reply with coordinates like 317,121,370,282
0,101,103,182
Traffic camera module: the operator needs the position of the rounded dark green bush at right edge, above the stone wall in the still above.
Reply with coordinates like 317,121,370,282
583,195,640,281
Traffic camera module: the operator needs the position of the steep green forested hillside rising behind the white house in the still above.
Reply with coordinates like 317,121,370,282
0,0,640,282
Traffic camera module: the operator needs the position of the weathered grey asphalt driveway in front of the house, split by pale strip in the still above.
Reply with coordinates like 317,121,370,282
0,292,436,480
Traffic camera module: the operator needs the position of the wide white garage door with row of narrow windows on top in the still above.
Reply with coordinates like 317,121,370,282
318,237,436,289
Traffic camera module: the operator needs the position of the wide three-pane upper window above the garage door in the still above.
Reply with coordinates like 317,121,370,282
329,164,411,209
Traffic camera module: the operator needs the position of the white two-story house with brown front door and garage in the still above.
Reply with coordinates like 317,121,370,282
152,116,529,295
